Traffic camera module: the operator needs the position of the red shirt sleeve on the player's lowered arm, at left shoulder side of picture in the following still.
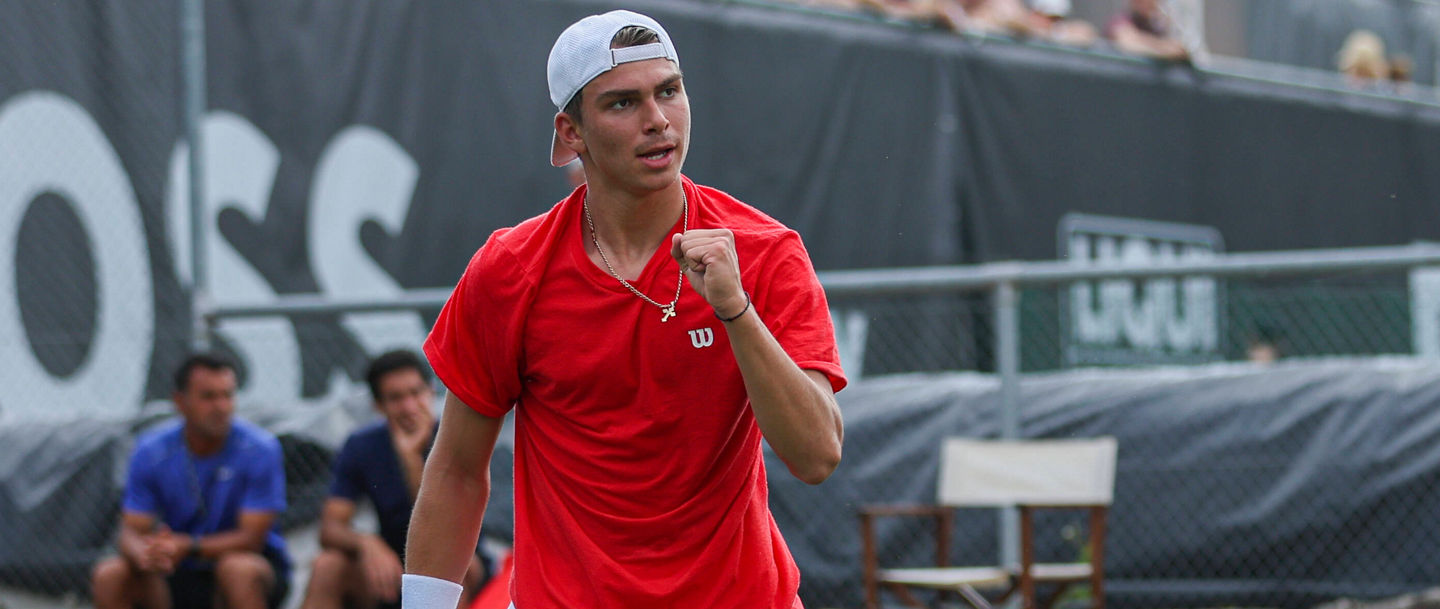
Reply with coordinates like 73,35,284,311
425,230,530,418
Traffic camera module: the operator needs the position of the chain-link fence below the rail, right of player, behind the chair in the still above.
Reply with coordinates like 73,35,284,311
812,248,1440,606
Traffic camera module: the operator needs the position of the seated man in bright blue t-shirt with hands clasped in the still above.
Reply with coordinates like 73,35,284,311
91,354,289,609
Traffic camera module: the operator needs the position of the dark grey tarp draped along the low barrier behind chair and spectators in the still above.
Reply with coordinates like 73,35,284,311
8,358,1440,608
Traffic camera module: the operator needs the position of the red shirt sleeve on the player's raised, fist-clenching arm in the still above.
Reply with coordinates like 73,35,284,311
750,230,848,392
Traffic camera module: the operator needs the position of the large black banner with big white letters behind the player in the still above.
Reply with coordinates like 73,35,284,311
0,0,1440,415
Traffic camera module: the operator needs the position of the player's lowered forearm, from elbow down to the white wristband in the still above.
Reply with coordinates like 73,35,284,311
405,451,490,583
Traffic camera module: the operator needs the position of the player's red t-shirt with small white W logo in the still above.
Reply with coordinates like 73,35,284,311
425,179,845,609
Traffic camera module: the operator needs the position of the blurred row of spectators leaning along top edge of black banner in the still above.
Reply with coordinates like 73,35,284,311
789,0,1189,62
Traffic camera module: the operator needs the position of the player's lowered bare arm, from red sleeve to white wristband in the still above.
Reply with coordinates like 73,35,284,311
405,393,504,583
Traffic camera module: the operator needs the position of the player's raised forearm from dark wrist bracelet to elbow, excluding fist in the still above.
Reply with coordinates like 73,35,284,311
724,308,844,484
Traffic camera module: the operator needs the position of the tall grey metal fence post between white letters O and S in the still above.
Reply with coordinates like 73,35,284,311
180,0,210,350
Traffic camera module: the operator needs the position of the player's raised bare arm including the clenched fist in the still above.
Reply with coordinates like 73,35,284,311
671,229,845,484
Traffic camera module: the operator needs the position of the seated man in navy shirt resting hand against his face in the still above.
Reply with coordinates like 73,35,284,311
304,351,490,609
